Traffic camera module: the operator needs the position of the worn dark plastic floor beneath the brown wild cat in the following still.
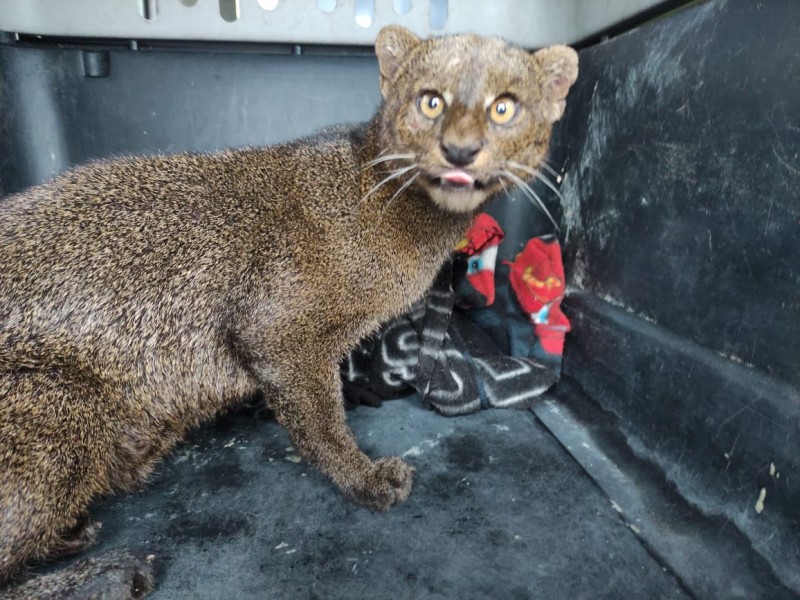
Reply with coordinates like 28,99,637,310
34,400,692,600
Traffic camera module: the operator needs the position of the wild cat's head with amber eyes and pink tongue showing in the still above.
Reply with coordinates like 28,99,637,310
375,25,578,212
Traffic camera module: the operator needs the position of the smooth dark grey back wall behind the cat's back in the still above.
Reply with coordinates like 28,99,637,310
0,44,380,196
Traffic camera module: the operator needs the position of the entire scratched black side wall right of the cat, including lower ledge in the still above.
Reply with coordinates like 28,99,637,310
556,0,800,592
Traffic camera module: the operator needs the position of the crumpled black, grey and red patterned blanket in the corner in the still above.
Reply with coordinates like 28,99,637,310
342,214,569,415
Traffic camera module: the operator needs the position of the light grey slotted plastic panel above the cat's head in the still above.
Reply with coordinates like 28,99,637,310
0,0,660,47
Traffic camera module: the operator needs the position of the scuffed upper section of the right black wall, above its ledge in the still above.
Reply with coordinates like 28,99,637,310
563,0,800,385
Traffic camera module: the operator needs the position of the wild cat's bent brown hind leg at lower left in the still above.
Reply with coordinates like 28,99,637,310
0,370,113,583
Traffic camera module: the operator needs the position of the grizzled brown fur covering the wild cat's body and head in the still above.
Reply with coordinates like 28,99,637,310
0,27,577,596
